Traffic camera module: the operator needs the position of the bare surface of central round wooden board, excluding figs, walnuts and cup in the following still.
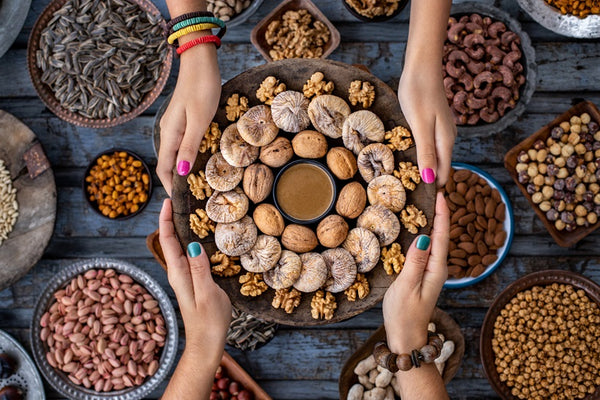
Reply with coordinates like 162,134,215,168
172,59,436,326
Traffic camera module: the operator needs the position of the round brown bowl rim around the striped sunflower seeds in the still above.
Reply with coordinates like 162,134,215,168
27,0,173,128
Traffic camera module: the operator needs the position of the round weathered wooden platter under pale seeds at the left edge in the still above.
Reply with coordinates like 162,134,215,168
0,110,56,290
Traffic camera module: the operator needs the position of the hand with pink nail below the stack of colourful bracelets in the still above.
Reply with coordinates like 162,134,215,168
156,39,221,196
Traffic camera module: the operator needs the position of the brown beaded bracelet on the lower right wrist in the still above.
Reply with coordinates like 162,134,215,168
373,331,443,373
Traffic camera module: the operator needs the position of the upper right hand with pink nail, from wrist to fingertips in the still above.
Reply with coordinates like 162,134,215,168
398,73,456,186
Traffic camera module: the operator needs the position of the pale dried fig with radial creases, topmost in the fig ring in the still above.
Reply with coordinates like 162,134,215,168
271,90,310,133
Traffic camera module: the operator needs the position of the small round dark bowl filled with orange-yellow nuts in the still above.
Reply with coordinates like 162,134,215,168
83,149,152,220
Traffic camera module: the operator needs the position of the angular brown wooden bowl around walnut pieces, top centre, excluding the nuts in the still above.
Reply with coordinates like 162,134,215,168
250,0,340,61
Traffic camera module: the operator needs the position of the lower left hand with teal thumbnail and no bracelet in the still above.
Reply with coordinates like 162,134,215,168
159,199,231,362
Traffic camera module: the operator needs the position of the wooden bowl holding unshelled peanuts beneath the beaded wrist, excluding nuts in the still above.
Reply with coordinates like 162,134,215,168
339,307,465,400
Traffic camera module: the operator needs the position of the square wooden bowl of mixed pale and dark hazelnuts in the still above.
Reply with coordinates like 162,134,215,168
504,101,600,247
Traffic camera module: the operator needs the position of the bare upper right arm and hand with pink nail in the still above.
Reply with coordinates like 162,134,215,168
398,0,456,185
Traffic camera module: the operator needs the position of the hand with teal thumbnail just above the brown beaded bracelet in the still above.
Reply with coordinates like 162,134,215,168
383,193,450,354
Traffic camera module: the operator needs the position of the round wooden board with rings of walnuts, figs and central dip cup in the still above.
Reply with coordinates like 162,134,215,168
173,59,435,326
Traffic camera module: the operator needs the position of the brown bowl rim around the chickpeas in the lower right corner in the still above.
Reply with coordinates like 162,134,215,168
479,270,600,400
